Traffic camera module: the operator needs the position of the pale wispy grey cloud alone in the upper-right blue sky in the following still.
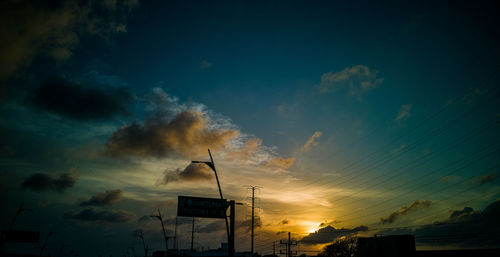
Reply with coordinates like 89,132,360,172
317,65,384,100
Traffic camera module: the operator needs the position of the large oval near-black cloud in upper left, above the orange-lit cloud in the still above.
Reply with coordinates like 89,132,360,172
33,78,133,120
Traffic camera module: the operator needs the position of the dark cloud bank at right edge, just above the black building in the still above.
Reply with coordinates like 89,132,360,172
378,199,500,247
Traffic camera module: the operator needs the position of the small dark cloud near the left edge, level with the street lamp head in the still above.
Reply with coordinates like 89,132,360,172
21,170,77,192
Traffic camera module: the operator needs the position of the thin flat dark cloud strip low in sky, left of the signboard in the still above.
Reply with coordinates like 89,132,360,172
64,208,136,223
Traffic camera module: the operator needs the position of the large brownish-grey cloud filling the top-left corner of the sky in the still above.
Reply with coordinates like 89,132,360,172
0,0,138,81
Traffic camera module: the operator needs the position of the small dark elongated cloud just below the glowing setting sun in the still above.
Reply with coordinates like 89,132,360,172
300,226,368,245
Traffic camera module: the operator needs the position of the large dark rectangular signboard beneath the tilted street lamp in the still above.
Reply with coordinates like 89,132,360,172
177,196,229,219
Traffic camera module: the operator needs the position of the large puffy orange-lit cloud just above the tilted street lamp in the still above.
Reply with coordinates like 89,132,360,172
105,110,238,157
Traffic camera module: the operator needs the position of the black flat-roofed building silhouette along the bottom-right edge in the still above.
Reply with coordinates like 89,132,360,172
358,235,500,257
